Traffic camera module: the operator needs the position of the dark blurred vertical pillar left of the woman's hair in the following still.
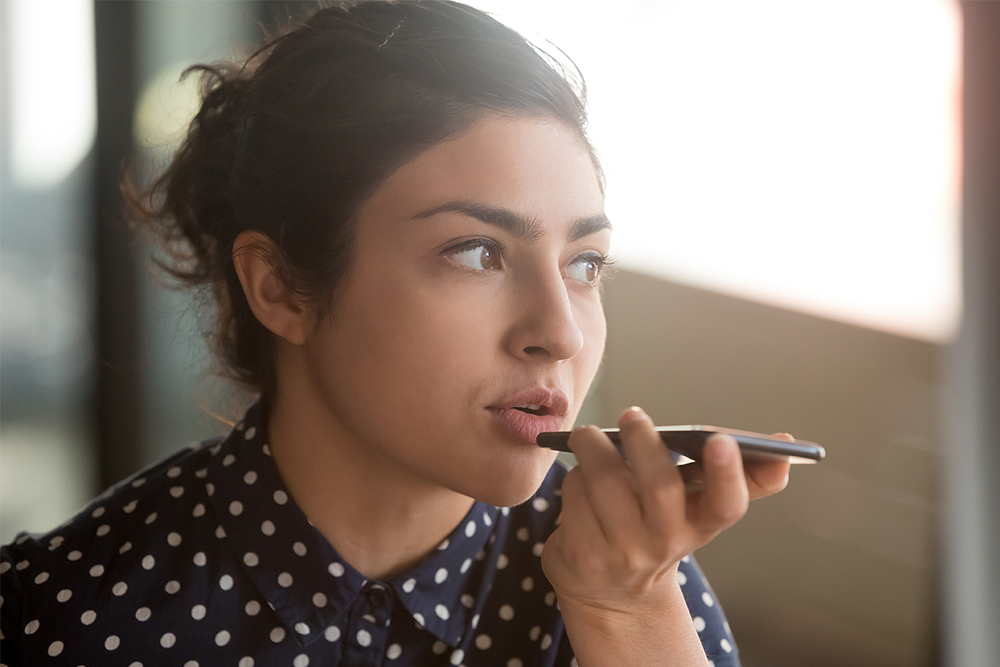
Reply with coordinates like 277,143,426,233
93,0,143,487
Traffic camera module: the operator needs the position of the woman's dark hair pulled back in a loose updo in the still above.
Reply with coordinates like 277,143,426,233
134,0,597,393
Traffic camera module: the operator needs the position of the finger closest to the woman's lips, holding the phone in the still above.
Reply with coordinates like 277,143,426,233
569,426,640,541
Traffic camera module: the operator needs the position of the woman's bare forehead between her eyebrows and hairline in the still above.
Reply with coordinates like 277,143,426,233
361,115,604,236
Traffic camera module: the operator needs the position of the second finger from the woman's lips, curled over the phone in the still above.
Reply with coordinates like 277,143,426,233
618,408,684,532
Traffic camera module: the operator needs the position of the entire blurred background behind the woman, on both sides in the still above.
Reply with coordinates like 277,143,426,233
0,0,984,667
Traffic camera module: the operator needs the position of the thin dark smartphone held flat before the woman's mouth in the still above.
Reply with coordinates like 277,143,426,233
535,426,826,465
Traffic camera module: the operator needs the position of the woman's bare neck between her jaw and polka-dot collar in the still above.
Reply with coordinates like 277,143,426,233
268,384,473,579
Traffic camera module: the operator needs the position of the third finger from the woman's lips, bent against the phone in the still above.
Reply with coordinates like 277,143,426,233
689,434,750,535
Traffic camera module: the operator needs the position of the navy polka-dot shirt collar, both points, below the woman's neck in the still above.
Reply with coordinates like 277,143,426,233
206,403,499,646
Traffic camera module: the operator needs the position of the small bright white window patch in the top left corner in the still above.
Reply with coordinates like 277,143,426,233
8,0,97,190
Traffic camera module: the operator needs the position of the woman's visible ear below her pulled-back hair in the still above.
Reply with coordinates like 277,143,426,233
233,232,309,345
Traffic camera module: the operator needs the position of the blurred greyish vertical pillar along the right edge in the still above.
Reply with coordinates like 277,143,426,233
942,0,1000,666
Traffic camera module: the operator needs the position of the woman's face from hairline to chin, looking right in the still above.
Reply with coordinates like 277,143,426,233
296,115,610,505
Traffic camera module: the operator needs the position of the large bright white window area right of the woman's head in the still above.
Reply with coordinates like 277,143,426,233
473,0,961,342
